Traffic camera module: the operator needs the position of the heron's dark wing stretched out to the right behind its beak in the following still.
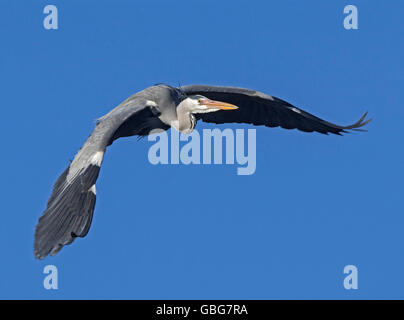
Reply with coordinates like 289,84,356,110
181,85,371,135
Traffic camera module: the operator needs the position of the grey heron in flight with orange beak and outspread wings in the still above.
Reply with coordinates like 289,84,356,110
34,84,372,259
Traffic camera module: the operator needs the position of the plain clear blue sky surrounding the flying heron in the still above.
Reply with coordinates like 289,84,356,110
0,0,404,299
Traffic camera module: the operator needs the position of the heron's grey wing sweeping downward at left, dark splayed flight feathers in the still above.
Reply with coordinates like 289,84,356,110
34,97,167,259
